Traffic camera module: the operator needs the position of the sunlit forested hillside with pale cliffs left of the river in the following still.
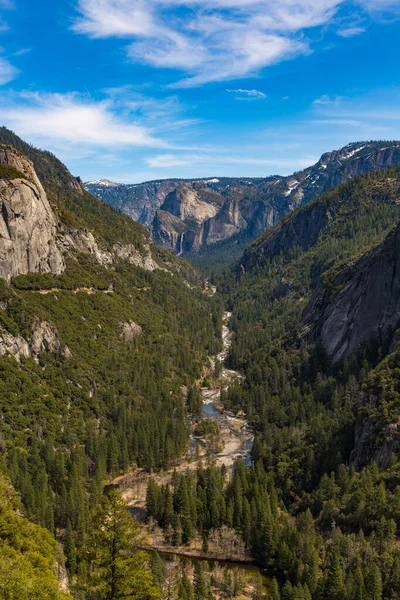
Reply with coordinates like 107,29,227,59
0,130,220,598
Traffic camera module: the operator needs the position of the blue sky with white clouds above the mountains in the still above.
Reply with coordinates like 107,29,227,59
0,0,400,183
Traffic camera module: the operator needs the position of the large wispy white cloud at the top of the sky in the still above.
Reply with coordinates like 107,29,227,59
73,0,354,87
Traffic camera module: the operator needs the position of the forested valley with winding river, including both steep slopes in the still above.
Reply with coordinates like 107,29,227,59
0,130,400,600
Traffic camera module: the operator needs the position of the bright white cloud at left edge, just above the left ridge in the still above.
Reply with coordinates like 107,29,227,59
0,92,168,149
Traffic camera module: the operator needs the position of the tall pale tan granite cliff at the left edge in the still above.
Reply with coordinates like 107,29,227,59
0,146,65,279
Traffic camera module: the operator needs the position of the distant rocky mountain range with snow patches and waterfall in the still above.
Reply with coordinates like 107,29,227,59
86,142,400,254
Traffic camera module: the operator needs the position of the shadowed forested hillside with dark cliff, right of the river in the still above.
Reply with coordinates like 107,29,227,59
205,162,400,600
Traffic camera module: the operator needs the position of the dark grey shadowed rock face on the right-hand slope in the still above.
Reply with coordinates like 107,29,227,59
300,225,400,362
